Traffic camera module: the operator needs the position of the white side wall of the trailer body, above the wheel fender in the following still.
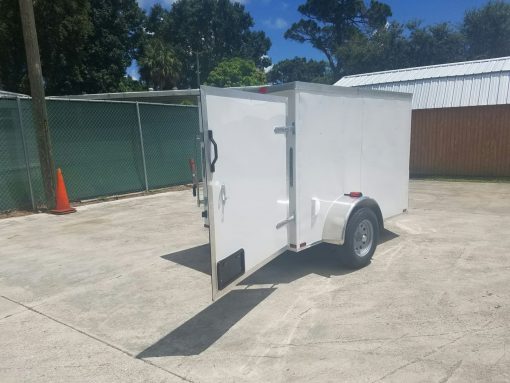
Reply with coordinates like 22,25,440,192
271,83,411,248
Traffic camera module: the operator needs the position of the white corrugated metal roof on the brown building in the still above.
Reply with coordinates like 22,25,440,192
335,57,510,109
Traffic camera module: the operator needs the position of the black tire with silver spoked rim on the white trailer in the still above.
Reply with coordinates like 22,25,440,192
342,208,379,269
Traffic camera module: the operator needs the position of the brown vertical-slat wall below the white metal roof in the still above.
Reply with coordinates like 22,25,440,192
410,105,510,177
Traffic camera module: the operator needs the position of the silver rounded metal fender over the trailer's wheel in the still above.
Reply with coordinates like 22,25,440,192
322,195,384,245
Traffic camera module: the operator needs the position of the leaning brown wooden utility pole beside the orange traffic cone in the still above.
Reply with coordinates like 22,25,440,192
19,0,55,209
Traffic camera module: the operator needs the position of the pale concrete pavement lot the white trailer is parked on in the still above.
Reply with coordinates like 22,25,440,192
0,181,510,382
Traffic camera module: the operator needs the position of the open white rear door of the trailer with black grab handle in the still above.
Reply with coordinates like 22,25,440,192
201,87,289,298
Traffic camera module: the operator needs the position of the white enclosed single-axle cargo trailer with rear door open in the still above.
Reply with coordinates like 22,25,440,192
194,82,411,299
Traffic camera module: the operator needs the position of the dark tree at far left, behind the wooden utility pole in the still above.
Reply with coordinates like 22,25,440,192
0,0,93,95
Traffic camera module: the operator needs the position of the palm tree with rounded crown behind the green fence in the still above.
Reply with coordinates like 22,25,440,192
138,38,181,90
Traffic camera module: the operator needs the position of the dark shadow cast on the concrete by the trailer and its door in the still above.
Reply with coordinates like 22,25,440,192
142,230,398,359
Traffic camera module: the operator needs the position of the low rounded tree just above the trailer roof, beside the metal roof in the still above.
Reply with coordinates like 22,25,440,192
267,57,332,84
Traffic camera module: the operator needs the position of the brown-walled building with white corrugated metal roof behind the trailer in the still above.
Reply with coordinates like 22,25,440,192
335,57,510,177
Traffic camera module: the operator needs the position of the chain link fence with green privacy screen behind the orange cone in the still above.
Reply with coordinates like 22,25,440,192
0,98,200,212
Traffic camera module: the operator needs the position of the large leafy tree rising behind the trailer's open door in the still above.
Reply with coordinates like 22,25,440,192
142,0,271,87
